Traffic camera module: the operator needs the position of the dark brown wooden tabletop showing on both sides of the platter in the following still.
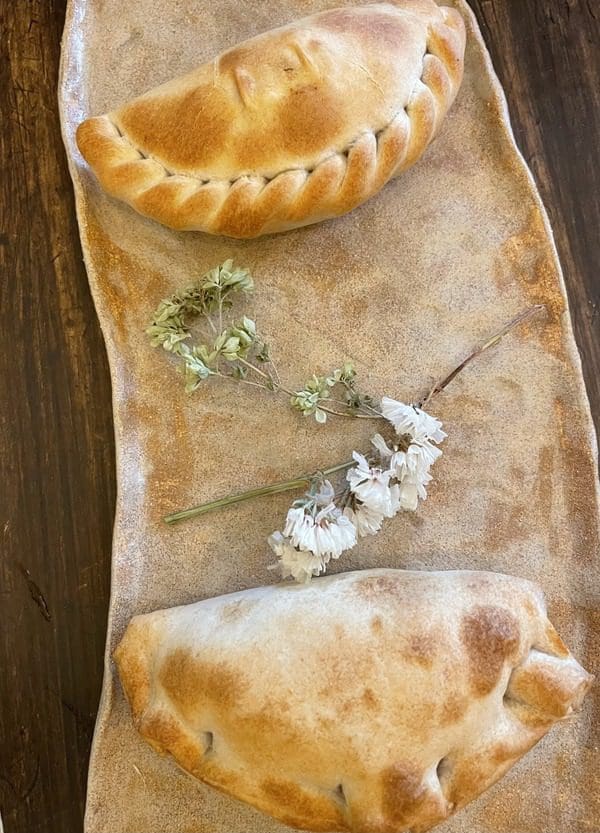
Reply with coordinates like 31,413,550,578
0,0,600,833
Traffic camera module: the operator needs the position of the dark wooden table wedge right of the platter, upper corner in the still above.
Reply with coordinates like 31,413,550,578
471,0,600,433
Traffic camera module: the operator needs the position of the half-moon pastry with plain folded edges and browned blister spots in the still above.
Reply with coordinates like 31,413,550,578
115,570,592,833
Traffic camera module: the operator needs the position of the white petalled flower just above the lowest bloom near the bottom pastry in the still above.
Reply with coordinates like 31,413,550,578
283,503,356,564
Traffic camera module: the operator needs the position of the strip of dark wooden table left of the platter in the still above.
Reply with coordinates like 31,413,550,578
0,0,115,833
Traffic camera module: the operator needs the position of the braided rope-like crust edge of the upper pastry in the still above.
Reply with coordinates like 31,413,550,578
77,7,465,238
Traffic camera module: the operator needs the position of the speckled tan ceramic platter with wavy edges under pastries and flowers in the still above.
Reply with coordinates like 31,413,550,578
60,0,600,833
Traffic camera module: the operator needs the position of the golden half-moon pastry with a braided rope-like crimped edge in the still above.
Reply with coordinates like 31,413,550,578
77,0,465,237
